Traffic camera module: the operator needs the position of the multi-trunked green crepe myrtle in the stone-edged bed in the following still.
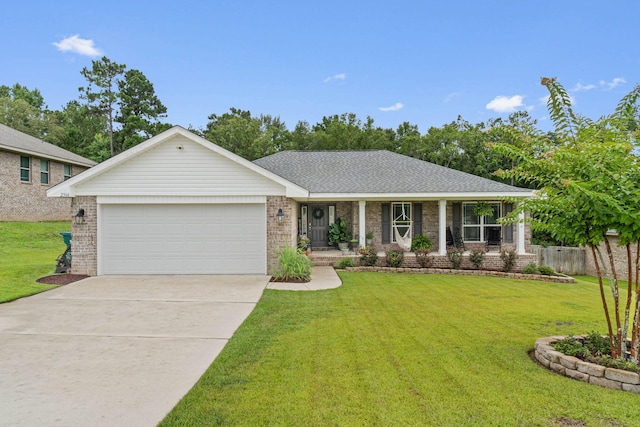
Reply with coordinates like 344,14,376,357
493,78,640,361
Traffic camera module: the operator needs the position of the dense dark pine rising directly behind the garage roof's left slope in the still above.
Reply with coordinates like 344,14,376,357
114,70,167,152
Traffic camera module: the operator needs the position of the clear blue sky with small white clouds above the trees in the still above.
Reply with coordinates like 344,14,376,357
0,0,640,132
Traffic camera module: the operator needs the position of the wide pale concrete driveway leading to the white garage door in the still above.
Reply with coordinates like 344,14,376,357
0,276,269,426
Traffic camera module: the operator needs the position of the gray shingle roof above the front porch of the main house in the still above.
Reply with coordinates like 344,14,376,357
255,150,531,195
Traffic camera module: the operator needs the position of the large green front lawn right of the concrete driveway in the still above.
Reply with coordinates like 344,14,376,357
161,273,640,427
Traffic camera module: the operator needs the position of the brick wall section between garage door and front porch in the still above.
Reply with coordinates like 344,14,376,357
267,196,300,274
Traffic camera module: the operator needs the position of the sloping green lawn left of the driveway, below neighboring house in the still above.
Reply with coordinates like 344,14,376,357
0,222,71,303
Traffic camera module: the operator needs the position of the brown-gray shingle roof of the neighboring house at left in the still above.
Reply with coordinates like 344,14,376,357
0,124,96,167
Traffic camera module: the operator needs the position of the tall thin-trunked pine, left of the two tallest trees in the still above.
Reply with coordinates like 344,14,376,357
78,56,126,156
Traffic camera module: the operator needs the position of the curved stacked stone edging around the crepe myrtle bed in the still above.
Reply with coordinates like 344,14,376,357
534,337,640,393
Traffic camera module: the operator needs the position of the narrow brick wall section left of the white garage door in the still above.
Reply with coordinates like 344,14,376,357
71,196,98,276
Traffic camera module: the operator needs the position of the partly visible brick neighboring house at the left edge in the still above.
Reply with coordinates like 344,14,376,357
0,124,96,221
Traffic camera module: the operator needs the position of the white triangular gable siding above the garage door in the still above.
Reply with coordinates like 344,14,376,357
76,136,285,196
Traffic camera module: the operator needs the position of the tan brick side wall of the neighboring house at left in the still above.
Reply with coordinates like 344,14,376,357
0,151,87,221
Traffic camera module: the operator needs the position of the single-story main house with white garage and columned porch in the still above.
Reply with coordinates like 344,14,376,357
47,127,531,275
